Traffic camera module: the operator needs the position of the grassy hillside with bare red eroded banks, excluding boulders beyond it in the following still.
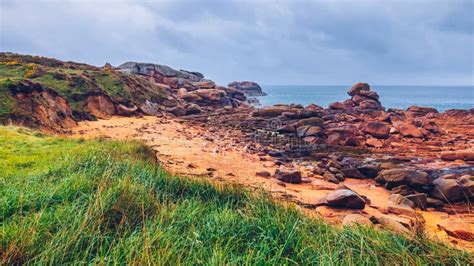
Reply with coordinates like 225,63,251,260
0,53,178,130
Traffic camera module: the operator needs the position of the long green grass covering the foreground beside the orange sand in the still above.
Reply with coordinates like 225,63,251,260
0,127,472,265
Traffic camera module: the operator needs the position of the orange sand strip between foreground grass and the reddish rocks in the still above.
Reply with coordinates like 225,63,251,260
68,116,474,251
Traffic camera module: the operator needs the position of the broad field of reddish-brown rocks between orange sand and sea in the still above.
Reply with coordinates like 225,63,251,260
208,81,472,212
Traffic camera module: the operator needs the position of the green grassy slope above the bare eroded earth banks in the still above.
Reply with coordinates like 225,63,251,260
0,53,169,125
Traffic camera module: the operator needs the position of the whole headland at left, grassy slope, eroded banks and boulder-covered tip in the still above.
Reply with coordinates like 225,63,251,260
0,53,252,130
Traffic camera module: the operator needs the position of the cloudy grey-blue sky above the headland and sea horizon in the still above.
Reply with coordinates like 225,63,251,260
0,0,474,85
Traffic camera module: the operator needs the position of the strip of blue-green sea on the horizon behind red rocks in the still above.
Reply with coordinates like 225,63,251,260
257,85,474,112
